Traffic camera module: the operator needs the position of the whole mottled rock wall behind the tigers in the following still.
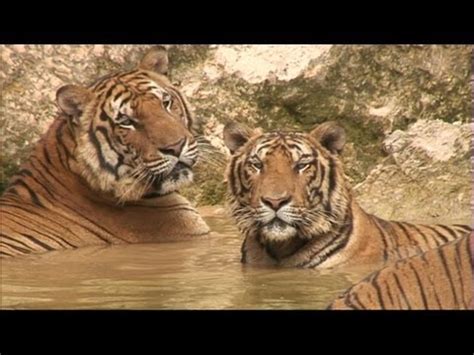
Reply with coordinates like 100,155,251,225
0,45,474,223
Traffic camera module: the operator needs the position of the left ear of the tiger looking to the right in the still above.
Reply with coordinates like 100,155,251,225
56,85,92,121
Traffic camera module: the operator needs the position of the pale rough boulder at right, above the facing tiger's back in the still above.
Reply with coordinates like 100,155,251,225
354,120,473,224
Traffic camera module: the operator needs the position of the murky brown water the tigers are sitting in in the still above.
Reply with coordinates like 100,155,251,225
1,207,372,309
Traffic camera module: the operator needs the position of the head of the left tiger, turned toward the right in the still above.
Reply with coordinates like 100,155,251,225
57,46,198,202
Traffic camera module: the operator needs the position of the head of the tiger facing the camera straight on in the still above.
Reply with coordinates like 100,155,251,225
224,122,350,243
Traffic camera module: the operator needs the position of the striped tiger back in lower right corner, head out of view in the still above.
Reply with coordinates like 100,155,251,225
328,236,474,310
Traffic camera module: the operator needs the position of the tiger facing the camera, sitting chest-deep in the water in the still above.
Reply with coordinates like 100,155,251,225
224,122,472,304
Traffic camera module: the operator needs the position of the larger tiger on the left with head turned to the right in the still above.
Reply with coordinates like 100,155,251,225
0,46,209,258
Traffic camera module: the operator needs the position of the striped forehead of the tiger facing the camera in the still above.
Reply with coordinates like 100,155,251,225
251,132,316,160
